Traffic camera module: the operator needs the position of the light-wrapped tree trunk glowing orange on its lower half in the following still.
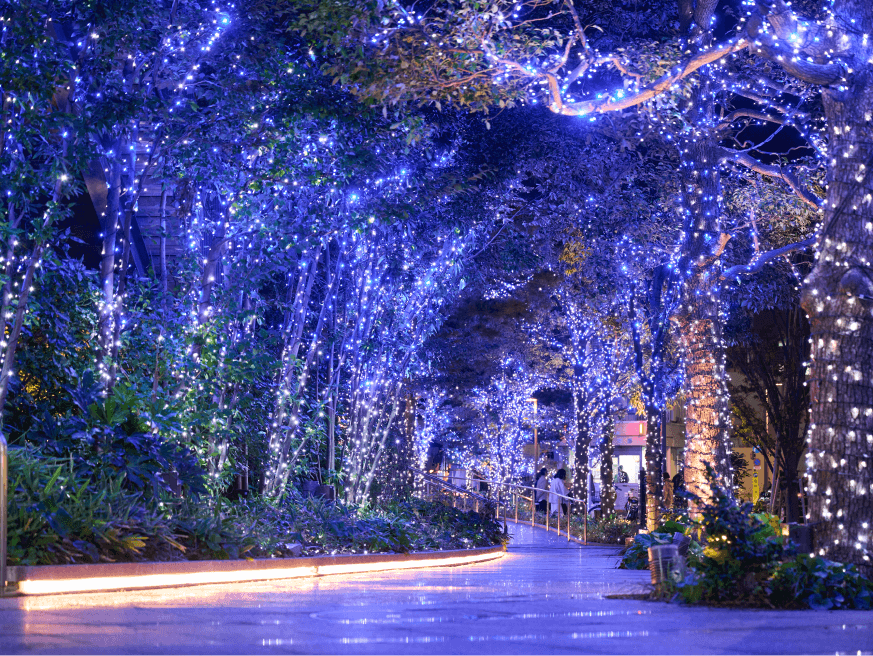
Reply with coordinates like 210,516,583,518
677,140,731,515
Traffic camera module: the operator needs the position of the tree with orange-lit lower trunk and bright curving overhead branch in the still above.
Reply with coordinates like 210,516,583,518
297,0,818,512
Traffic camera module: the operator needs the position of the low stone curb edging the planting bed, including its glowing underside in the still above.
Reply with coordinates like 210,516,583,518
3,545,506,595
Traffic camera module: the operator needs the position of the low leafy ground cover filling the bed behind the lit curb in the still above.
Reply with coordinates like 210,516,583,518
9,448,504,565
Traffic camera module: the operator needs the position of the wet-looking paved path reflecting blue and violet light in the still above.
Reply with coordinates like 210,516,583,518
0,525,873,656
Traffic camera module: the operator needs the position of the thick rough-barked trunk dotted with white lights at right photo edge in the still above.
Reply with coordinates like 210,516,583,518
802,70,873,576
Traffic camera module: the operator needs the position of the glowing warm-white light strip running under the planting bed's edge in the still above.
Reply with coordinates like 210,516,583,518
8,547,505,595
